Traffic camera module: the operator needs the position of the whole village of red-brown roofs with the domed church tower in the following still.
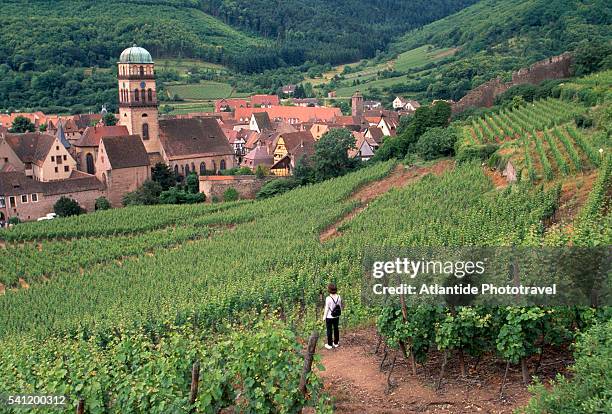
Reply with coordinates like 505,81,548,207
0,46,420,225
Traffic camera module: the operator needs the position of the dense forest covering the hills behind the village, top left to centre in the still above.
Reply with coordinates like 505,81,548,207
0,0,475,112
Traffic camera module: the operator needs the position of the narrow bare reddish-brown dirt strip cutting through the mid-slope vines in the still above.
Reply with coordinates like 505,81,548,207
319,160,454,243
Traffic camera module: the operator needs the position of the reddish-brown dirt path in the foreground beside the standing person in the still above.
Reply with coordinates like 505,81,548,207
318,328,546,414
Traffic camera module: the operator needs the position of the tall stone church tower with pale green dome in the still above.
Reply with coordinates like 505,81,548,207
118,45,161,153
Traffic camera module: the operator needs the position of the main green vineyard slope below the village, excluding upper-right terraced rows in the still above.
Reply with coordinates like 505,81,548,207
0,151,610,413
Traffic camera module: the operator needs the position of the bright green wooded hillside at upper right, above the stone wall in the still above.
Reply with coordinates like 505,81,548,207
390,0,612,100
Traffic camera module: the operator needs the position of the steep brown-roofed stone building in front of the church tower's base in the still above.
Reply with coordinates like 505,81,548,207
96,135,151,207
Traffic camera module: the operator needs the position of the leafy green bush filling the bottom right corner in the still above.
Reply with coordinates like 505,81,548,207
523,320,612,414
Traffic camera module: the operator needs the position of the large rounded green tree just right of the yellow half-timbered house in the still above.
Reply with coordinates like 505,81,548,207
312,128,355,181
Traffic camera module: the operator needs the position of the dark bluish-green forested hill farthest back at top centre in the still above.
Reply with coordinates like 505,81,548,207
201,0,478,65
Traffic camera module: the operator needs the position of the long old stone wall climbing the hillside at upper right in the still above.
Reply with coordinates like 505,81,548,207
453,52,572,113
